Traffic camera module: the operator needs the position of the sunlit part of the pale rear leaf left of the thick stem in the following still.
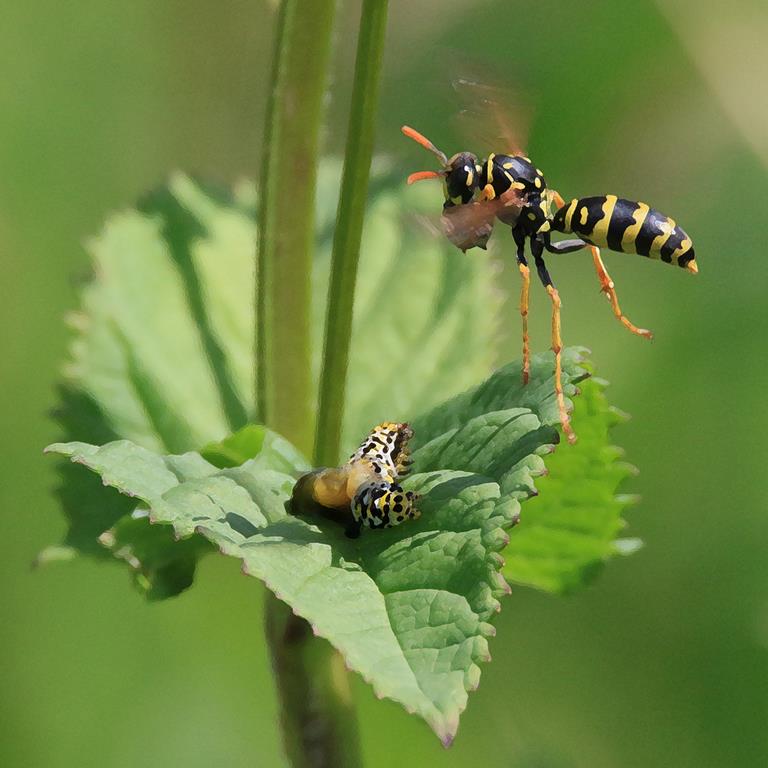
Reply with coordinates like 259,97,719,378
67,175,255,451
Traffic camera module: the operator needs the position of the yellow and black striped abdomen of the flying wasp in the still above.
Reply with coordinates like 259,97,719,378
551,195,697,272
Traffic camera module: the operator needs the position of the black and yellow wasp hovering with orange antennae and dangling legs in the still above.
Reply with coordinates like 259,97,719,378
401,125,698,443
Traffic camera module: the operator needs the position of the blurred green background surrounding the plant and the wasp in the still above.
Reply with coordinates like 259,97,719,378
0,0,768,768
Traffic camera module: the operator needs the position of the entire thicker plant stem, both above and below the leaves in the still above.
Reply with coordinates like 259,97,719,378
256,0,360,768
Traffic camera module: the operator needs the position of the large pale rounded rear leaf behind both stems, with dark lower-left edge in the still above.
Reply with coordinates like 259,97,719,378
45,168,499,596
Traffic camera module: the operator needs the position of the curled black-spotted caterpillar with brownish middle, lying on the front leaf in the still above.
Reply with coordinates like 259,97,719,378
290,422,420,539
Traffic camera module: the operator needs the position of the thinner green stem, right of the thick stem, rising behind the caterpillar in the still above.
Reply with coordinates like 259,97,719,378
315,0,387,466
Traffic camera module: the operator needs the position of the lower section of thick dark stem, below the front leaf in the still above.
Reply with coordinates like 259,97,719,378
265,592,361,768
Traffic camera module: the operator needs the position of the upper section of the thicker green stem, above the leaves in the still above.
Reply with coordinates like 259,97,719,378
255,0,335,454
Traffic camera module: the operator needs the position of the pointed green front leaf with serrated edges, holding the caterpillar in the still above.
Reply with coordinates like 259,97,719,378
48,376,556,743
